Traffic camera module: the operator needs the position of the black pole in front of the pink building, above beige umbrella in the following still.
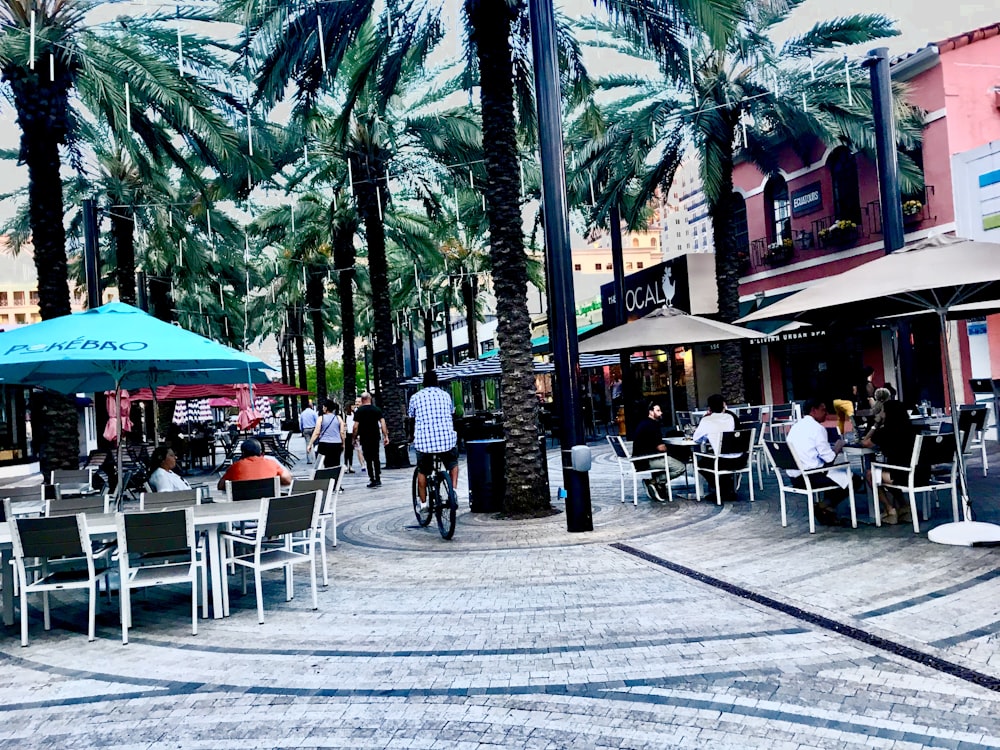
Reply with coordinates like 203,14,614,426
864,47,903,254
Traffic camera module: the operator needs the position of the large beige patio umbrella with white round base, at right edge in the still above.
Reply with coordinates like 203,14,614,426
739,236,1000,545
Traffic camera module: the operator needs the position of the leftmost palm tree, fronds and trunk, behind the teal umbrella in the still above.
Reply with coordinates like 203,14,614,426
0,0,248,469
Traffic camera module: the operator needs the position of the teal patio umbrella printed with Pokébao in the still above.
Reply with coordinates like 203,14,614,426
0,302,273,502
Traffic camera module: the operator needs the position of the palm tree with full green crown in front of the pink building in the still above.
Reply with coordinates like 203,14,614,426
576,3,920,403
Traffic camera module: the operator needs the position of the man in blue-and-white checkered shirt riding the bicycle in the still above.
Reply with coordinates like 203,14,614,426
409,370,458,512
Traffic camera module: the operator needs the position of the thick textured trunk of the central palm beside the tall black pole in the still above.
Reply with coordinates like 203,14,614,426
466,0,550,513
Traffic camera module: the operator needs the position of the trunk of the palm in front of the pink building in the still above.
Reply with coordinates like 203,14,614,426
708,123,745,404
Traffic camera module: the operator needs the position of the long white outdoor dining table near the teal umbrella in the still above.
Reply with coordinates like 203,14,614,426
0,501,260,625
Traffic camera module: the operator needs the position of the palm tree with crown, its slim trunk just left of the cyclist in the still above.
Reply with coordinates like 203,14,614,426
247,2,478,466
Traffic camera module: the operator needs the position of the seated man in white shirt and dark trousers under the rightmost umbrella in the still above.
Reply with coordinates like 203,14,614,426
786,399,851,524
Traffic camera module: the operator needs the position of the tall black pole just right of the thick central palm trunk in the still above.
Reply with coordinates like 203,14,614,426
528,0,594,532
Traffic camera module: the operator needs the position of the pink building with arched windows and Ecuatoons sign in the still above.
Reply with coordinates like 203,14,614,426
734,24,1000,403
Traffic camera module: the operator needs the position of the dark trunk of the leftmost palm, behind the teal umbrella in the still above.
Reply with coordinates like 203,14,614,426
3,66,80,474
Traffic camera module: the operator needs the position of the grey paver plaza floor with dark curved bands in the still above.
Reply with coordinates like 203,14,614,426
0,441,1000,749
